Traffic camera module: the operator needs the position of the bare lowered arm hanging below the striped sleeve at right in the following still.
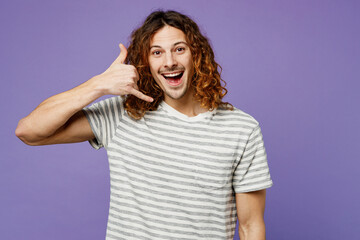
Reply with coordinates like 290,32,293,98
236,189,266,240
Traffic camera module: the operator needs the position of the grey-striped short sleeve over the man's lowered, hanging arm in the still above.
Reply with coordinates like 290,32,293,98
233,125,273,193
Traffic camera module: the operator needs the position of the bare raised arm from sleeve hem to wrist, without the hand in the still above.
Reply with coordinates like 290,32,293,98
15,79,101,145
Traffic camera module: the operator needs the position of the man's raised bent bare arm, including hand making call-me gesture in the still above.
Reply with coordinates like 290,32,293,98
15,44,152,145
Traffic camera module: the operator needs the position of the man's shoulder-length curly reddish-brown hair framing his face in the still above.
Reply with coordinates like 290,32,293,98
124,11,233,119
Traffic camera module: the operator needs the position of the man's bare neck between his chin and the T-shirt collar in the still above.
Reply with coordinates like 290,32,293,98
164,88,208,117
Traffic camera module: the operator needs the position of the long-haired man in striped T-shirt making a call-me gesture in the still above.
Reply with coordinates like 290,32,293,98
16,11,272,240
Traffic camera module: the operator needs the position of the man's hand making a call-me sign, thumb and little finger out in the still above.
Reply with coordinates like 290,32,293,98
98,43,153,102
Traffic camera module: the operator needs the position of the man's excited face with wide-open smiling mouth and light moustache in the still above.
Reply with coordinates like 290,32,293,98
149,26,194,103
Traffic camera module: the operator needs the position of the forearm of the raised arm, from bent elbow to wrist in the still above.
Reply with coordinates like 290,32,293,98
16,76,103,142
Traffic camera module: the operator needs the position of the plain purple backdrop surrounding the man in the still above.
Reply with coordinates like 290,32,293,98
0,0,360,240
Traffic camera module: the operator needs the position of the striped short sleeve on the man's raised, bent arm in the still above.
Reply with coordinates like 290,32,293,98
83,96,123,149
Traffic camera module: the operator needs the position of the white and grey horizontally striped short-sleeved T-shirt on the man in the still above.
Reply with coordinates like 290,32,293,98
84,97,272,240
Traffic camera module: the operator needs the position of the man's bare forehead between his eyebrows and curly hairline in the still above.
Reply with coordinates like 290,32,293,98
150,26,186,48
